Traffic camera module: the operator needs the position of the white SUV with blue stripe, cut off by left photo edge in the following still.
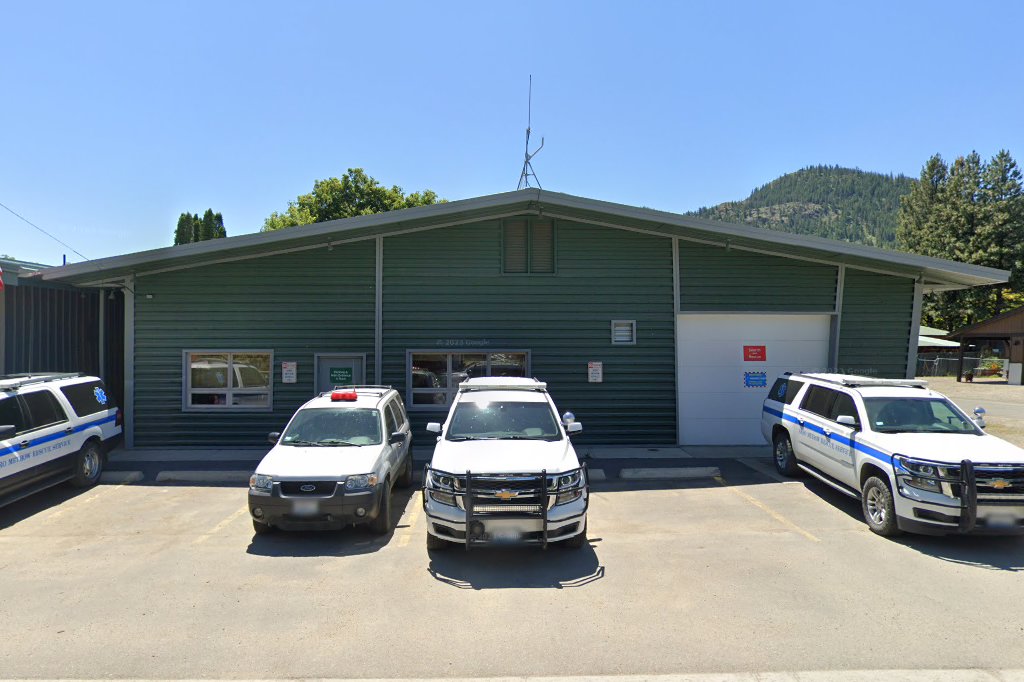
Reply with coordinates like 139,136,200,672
0,374,121,505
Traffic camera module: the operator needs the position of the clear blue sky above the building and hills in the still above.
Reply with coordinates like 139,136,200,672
0,0,1024,263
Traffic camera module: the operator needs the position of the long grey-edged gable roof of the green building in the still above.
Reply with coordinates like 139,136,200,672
29,188,1010,291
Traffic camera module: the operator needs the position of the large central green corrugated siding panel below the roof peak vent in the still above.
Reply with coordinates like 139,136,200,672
383,221,676,443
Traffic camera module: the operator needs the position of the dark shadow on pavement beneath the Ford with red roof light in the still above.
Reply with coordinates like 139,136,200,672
246,487,417,557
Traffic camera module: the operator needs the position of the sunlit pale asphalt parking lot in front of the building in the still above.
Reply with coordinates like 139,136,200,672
0,461,1024,678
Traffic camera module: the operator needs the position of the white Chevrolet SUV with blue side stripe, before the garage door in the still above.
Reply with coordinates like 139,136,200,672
761,374,1024,536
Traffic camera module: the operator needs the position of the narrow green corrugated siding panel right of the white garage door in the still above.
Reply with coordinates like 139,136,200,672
839,268,913,379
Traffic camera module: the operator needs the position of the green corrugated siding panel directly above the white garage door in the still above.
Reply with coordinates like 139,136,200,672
679,241,839,312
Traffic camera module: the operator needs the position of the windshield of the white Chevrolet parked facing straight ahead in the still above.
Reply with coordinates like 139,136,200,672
446,401,562,440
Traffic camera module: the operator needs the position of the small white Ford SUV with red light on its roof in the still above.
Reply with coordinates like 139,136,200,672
249,386,413,535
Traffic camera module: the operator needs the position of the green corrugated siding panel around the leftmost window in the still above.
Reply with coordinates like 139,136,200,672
135,241,376,445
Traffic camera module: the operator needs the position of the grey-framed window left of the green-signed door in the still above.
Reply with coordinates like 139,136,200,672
183,350,273,412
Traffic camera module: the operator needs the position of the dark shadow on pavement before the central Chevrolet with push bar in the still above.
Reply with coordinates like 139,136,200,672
427,538,604,590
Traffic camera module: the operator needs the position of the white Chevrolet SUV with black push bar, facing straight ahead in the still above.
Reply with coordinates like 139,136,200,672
423,377,589,550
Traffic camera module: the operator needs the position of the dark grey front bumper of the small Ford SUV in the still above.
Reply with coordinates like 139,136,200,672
249,481,382,530
